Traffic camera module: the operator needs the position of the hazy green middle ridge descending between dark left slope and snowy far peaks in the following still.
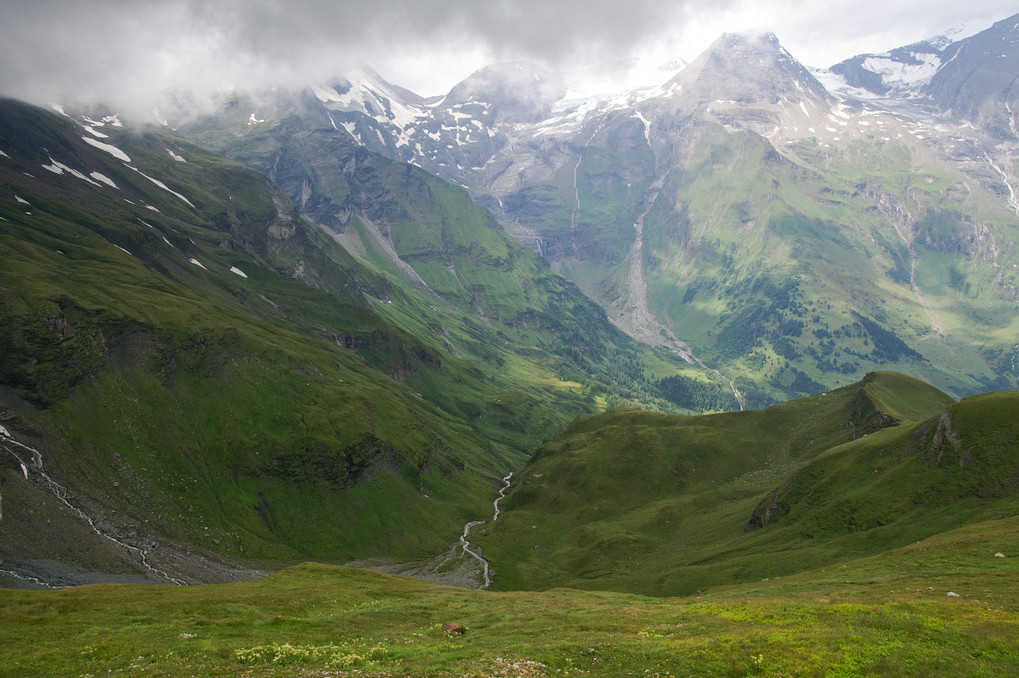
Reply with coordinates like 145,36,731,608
183,93,737,418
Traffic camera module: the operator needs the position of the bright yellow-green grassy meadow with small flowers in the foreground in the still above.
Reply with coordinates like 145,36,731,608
0,518,1019,676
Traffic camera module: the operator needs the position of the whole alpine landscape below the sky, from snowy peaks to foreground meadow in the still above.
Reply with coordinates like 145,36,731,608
0,9,1019,676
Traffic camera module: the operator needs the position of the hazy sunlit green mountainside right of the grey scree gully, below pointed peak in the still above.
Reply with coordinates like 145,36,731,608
645,123,1017,398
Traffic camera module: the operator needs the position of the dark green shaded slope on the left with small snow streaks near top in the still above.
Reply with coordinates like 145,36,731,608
0,99,548,559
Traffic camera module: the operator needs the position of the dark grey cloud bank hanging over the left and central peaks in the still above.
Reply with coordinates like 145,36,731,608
0,0,725,105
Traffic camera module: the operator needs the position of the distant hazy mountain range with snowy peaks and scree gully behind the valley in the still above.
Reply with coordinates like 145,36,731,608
182,14,1019,406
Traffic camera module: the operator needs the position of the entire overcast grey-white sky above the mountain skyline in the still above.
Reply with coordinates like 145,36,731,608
0,0,1017,115
